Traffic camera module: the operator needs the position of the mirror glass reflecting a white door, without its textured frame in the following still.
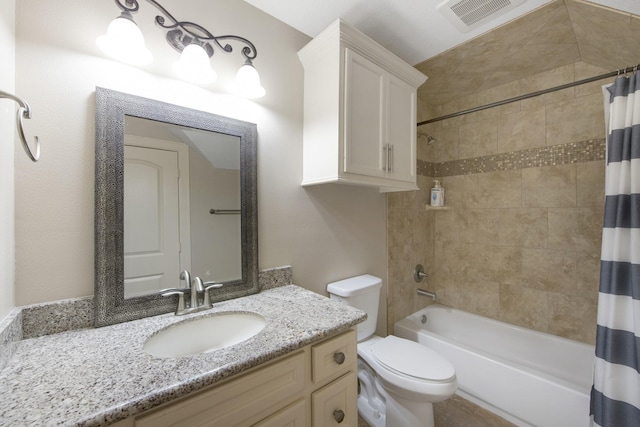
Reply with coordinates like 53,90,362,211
124,116,242,298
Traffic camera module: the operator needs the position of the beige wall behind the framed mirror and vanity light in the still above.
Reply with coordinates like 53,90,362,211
16,0,386,314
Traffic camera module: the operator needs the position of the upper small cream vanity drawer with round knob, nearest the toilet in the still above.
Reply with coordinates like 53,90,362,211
311,330,358,384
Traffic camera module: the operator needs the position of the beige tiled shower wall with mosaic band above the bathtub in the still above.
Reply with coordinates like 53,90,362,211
388,23,616,350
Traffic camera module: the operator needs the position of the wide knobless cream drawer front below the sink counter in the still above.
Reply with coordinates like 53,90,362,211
135,353,305,427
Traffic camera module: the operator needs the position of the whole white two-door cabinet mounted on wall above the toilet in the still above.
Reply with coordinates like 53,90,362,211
298,20,426,191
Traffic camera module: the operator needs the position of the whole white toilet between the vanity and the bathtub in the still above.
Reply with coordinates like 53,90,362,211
327,274,458,427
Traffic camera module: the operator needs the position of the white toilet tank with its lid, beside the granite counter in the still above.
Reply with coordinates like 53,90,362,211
327,274,382,341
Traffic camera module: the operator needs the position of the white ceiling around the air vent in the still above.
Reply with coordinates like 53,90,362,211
245,0,640,65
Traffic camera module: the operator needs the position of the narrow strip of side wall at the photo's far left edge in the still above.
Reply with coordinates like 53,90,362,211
0,0,15,321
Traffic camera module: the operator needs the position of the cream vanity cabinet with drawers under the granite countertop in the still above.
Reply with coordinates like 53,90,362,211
116,329,358,427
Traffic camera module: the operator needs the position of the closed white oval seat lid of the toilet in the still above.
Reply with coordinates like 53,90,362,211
371,335,456,382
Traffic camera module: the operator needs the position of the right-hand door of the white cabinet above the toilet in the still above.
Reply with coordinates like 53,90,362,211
386,75,417,183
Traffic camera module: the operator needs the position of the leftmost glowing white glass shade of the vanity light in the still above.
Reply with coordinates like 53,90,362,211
96,13,153,65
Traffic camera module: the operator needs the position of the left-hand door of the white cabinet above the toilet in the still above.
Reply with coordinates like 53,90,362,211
342,48,387,177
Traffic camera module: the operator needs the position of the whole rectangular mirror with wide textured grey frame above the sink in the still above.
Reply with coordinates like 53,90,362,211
95,88,259,326
